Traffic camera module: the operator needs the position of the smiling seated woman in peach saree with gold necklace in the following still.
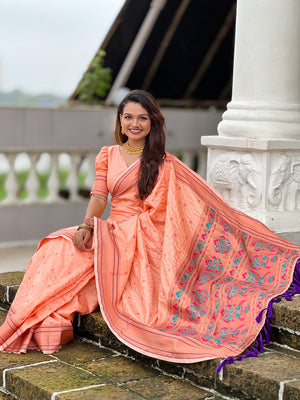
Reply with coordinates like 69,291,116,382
0,90,299,362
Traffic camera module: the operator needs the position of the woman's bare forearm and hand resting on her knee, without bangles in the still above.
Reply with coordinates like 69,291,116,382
74,195,107,250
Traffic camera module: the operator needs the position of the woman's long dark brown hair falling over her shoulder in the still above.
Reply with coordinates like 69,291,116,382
115,90,166,200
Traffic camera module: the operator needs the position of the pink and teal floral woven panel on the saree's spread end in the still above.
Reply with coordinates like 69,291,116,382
161,203,298,354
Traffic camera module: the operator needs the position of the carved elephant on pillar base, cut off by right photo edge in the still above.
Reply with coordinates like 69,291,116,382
268,154,300,211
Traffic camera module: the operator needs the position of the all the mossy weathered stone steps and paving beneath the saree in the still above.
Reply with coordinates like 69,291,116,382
0,272,300,400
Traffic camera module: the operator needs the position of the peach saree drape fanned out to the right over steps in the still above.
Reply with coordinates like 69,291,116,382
94,155,299,363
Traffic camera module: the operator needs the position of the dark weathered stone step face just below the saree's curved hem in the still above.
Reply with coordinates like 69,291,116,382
75,312,300,400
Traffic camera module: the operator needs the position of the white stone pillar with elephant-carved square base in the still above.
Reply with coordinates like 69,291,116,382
202,0,300,232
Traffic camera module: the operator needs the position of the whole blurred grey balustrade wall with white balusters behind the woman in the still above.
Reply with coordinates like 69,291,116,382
0,107,222,241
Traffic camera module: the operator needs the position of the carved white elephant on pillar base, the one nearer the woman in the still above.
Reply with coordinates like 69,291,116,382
211,153,262,210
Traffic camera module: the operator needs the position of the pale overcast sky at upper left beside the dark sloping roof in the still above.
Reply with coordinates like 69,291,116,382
0,0,125,97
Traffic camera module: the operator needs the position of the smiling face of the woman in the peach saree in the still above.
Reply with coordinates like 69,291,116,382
120,102,151,147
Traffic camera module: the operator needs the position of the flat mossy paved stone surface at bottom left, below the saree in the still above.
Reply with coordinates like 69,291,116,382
0,339,216,400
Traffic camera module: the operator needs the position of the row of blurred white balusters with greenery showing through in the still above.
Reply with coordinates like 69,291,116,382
0,149,206,207
